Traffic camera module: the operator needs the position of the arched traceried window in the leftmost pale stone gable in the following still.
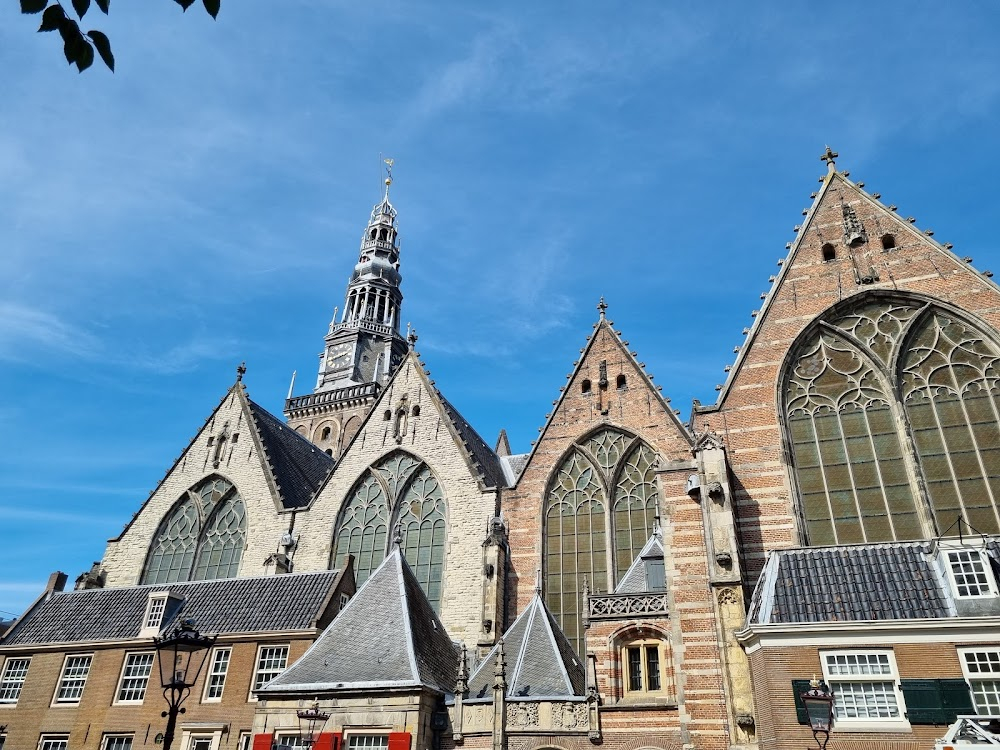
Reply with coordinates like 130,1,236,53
141,476,246,583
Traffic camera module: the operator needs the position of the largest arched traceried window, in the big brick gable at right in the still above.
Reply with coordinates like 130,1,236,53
783,295,1000,545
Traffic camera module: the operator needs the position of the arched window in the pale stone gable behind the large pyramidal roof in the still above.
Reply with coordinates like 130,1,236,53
333,452,447,610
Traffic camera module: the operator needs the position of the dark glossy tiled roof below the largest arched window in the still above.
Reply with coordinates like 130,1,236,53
747,542,955,625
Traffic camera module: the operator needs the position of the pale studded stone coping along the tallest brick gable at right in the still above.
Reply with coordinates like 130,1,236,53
691,165,1000,422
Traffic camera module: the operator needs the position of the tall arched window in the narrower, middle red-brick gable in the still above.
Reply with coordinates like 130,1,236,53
543,428,658,647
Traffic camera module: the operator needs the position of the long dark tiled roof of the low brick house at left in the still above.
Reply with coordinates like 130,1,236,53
0,570,339,646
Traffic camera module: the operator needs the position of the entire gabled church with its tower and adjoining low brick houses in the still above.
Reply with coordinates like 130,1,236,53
0,148,1000,750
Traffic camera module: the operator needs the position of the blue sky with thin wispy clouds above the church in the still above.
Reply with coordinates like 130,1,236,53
0,0,1000,616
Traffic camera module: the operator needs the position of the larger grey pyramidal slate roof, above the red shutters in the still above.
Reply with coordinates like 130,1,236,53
261,548,458,695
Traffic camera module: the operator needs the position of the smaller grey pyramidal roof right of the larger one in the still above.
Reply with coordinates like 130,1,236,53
466,593,586,702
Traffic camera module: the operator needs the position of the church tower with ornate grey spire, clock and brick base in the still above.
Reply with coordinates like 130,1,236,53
285,159,407,458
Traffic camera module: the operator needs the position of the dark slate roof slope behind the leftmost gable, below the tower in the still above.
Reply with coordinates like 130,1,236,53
247,398,335,508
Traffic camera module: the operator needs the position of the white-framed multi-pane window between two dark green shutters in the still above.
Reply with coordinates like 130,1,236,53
820,651,910,730
